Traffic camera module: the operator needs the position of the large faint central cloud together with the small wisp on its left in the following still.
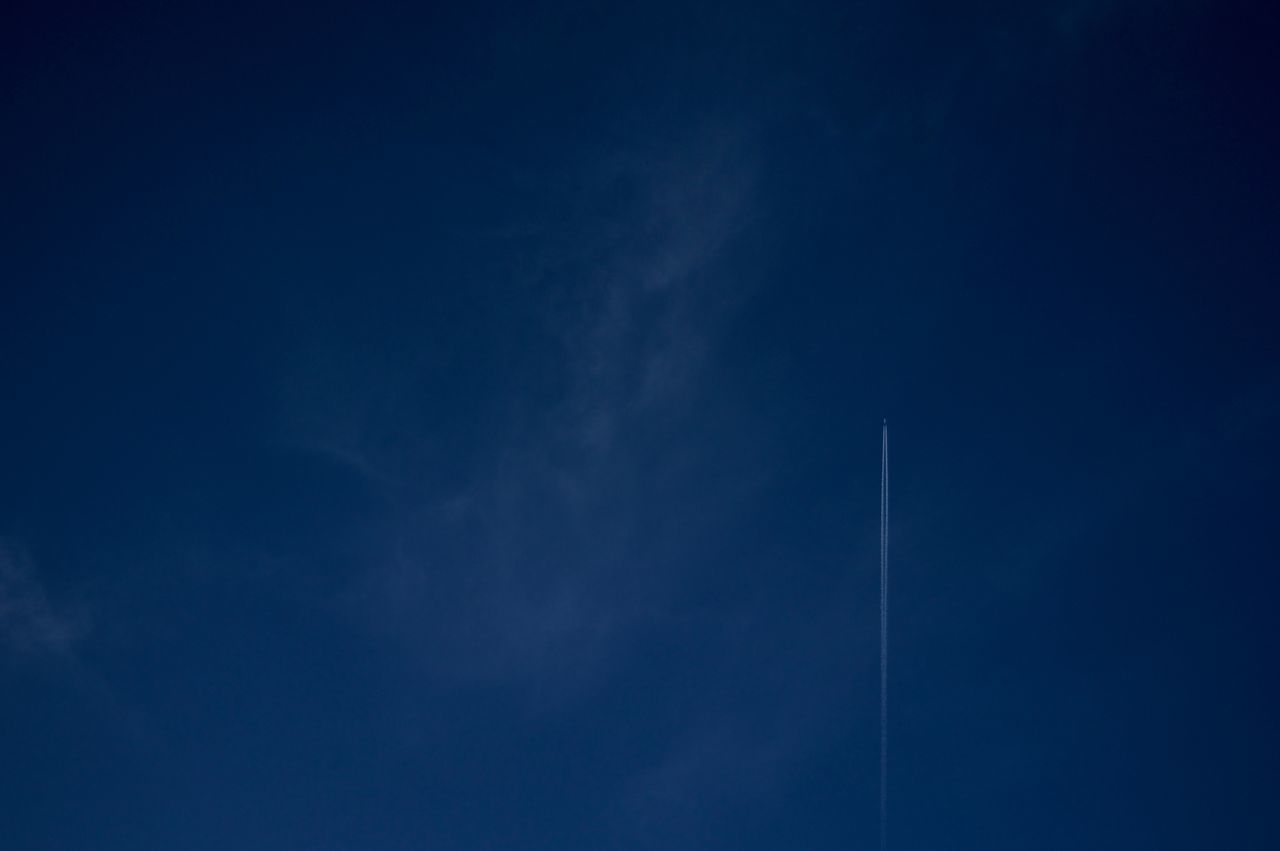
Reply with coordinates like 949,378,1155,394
268,127,758,694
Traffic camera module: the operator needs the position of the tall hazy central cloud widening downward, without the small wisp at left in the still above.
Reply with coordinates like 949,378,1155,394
366,122,754,688
